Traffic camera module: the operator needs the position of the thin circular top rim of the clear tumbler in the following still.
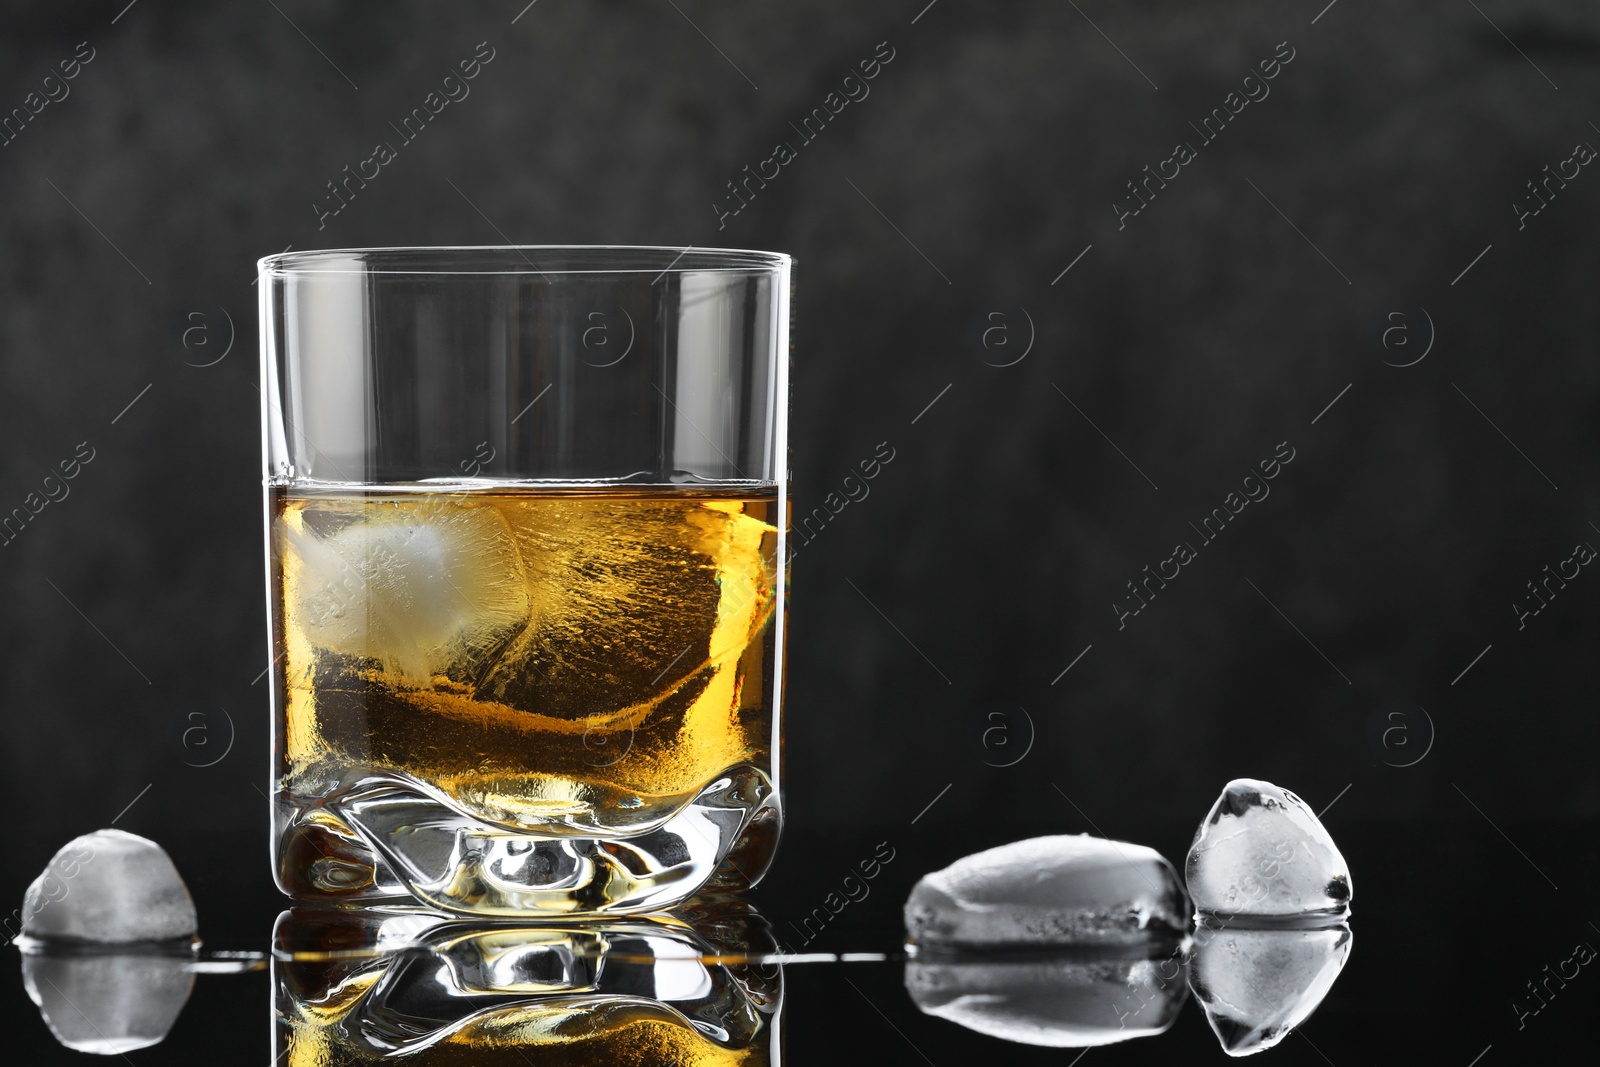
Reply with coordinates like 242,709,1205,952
256,245,795,277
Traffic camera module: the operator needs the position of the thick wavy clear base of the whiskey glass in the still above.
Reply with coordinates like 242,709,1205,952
274,766,782,918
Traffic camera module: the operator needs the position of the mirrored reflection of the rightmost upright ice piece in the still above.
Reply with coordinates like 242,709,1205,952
1189,926,1350,1056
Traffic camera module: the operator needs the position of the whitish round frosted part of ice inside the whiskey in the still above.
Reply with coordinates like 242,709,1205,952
283,504,528,681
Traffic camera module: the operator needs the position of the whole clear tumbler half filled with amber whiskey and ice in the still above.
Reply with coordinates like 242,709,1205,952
261,248,789,918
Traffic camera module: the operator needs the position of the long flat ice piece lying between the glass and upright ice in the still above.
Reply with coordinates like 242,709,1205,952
906,835,1189,950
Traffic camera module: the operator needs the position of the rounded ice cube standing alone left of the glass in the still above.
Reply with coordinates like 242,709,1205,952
22,830,195,942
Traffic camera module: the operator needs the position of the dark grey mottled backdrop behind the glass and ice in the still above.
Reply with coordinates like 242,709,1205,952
0,0,1600,1067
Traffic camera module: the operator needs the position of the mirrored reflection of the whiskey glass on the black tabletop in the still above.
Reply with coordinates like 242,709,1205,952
272,904,782,1067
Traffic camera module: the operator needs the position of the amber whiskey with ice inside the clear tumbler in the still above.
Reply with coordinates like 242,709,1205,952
270,486,781,896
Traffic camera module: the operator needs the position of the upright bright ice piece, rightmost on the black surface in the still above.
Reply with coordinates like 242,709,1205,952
1186,777,1350,921
